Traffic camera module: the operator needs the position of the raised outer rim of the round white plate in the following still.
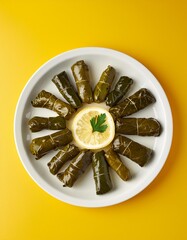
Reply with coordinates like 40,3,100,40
13,47,173,208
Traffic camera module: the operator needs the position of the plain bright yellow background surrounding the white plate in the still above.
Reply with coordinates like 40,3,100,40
0,0,187,240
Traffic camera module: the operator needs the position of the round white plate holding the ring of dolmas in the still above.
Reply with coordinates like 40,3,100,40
14,47,173,207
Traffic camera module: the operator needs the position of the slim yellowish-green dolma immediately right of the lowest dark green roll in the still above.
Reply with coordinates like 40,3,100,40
105,148,130,181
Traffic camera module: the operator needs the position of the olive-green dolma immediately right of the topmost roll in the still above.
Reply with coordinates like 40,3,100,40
93,65,115,103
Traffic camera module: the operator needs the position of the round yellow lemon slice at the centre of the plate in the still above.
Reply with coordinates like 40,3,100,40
72,107,115,149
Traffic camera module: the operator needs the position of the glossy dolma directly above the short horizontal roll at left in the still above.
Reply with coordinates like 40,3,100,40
31,90,75,120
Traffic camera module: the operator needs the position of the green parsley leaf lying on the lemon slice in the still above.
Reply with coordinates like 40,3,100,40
90,113,108,132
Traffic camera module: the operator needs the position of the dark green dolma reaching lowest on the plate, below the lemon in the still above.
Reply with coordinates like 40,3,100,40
92,150,112,195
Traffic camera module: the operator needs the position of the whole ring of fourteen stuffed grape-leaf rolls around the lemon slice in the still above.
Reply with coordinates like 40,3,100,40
28,60,161,195
